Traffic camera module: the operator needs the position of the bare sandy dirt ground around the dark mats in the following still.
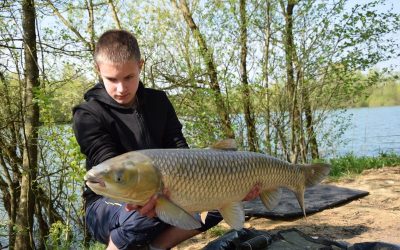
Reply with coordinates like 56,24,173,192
174,166,400,249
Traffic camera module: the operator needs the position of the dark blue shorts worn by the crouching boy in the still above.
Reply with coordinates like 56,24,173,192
86,197,222,249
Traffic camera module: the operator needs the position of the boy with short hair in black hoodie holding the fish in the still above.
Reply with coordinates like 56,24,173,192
73,30,258,249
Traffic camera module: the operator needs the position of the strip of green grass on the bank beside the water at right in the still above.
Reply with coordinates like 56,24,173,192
329,153,400,179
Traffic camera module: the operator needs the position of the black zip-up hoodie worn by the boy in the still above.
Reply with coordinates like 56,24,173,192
73,83,188,204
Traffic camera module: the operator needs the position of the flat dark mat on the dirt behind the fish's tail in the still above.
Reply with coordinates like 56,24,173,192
244,185,369,220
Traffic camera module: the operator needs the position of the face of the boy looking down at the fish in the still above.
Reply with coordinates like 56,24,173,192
96,60,143,106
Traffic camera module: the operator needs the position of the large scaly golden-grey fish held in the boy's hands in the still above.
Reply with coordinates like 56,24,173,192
85,140,330,230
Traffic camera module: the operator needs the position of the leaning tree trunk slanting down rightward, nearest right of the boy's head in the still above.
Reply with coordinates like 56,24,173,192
172,0,235,138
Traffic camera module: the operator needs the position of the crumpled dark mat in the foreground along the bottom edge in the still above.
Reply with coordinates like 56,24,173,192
203,229,400,250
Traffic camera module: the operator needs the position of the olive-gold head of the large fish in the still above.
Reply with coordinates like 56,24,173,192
84,152,162,205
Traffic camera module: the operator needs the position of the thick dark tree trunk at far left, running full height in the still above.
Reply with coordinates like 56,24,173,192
15,0,39,250
